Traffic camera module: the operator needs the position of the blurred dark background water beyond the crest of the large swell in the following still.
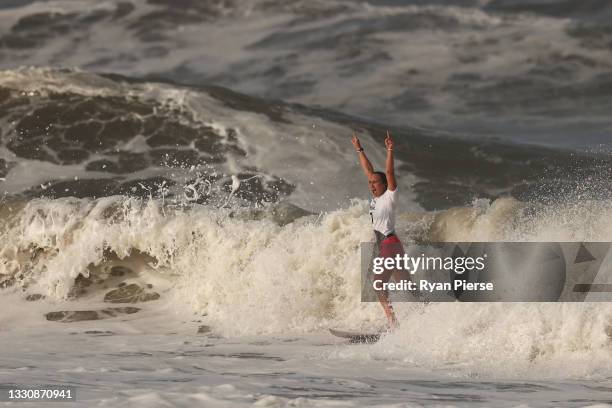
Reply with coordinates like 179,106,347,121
0,0,612,150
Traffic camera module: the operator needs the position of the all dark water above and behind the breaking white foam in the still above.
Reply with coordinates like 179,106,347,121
0,0,612,210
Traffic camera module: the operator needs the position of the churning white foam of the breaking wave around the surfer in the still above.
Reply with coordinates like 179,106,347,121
1,197,612,378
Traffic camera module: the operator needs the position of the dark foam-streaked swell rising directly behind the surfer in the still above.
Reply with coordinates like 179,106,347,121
0,68,612,211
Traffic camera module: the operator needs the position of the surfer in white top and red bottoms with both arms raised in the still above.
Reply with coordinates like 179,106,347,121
352,131,404,329
